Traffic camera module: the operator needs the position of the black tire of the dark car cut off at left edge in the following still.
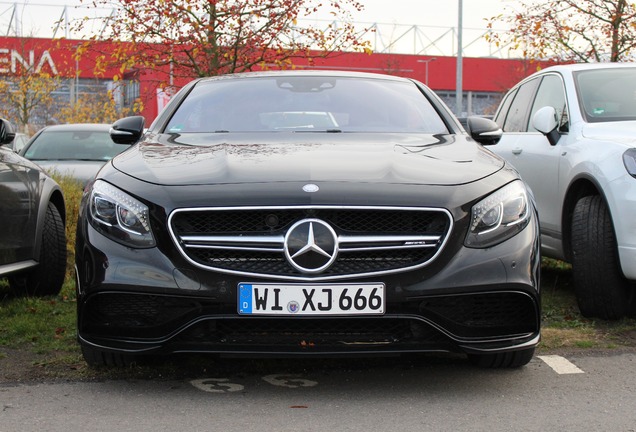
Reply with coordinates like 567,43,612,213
9,203,67,297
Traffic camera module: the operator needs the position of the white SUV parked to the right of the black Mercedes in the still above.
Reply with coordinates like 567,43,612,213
489,63,636,319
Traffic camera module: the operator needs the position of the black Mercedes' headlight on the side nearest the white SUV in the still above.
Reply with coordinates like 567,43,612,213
465,181,530,248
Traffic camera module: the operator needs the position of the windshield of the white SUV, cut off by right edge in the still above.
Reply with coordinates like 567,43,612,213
574,68,636,123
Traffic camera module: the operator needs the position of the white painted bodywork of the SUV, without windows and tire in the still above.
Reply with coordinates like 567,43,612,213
489,64,636,280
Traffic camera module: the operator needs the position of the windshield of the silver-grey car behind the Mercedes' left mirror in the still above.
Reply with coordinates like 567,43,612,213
24,129,128,161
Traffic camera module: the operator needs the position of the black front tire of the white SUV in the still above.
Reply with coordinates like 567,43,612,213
571,195,634,320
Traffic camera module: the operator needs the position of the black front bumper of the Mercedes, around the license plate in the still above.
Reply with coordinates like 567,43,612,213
76,211,540,355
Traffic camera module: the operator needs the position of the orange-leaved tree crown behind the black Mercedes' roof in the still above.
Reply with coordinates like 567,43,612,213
77,0,368,88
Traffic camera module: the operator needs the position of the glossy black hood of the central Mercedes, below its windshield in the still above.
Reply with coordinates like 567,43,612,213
112,133,504,186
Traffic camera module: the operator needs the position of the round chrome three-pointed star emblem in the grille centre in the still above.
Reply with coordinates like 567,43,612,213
285,219,338,273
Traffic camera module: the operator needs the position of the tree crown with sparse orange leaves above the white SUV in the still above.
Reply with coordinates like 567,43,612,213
487,0,636,62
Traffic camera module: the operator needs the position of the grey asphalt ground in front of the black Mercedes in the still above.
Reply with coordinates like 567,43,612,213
0,352,636,431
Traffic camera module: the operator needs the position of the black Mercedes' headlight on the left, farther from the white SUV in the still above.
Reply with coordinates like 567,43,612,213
89,180,155,248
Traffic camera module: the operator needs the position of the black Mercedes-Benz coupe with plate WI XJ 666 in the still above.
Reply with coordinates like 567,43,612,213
76,71,540,367
